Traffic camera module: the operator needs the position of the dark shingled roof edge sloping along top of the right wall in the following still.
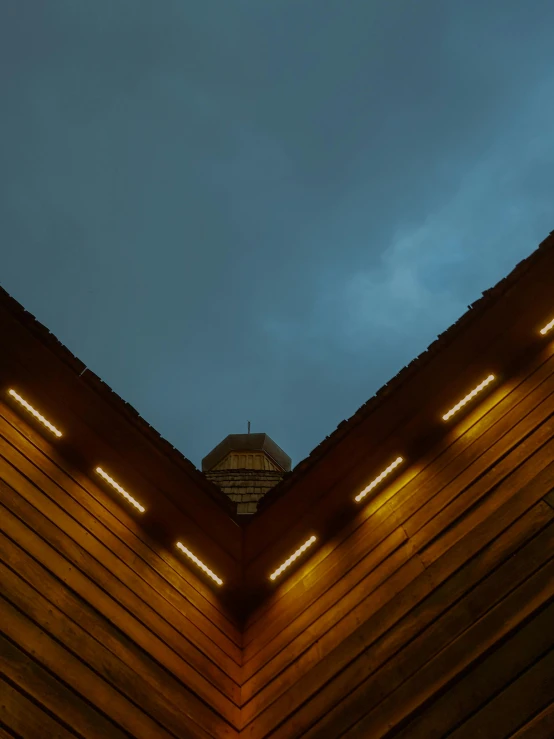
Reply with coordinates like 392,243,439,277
258,231,554,513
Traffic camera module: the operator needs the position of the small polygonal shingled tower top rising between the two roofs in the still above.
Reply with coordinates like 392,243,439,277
202,433,291,513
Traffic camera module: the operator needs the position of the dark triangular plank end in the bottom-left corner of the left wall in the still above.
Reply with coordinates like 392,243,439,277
0,681,78,739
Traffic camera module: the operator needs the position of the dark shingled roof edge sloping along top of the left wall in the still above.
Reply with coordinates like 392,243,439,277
0,285,236,519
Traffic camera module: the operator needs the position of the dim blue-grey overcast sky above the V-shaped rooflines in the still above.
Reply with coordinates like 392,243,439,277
0,0,554,466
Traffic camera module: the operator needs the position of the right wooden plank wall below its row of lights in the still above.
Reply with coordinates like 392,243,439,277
241,342,554,739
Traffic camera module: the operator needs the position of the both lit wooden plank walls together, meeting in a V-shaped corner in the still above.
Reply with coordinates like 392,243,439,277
0,342,554,739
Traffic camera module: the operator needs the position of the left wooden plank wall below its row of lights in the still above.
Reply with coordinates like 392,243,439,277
0,403,241,739
